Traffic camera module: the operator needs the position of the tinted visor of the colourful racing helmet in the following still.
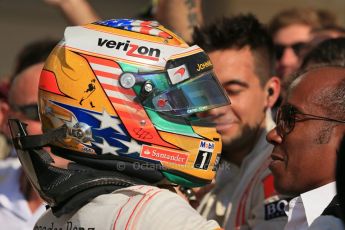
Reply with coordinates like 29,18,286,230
150,71,229,116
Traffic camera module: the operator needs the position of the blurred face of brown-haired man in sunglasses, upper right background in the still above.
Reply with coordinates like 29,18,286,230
273,24,311,78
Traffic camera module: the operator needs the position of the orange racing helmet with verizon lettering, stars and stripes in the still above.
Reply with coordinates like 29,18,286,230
13,19,230,187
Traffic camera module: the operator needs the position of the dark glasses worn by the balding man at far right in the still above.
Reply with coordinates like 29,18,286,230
276,104,345,137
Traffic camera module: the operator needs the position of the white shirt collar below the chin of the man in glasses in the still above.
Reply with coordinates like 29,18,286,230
300,182,337,226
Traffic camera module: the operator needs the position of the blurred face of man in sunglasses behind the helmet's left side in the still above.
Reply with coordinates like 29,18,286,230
9,63,43,134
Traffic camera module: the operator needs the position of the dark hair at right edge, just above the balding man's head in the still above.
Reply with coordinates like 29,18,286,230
301,38,345,69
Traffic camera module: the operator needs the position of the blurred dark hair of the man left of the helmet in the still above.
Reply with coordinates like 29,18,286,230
13,39,58,76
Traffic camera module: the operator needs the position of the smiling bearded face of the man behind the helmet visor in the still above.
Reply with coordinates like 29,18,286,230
209,48,266,157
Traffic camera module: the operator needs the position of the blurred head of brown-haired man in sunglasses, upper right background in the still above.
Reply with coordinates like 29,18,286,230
269,8,337,79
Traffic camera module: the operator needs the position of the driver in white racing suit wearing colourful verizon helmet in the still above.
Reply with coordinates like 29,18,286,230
9,19,230,229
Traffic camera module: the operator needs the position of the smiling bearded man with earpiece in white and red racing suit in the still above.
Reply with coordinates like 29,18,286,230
193,15,287,229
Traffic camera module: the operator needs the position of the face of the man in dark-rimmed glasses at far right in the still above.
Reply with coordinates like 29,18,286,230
267,68,345,195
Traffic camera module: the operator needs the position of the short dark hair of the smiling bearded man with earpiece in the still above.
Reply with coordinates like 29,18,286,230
193,14,274,85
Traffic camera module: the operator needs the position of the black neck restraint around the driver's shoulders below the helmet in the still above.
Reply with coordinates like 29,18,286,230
9,119,159,207
